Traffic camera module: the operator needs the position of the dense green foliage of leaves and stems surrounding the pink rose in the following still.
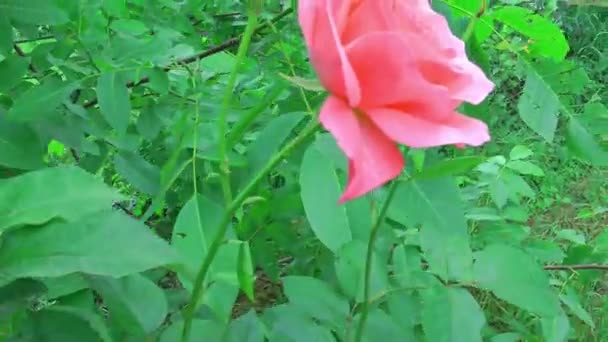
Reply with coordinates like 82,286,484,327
0,0,608,342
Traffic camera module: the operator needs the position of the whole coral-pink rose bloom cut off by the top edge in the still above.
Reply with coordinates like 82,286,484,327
298,0,494,203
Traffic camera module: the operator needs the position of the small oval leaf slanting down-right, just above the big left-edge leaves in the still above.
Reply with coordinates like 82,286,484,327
114,151,160,195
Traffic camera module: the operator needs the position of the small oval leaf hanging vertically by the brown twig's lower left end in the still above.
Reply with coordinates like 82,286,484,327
97,72,131,134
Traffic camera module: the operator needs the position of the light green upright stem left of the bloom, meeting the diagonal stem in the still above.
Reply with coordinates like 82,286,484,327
218,10,258,206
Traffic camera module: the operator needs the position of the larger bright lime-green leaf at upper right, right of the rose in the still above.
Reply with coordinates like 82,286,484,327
492,6,570,61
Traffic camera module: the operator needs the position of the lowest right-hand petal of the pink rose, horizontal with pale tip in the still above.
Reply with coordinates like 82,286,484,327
366,108,490,148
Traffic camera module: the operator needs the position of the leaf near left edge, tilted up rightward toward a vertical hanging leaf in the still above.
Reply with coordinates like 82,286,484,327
6,78,76,121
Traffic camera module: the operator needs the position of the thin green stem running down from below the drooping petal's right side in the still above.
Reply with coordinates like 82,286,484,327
355,180,399,342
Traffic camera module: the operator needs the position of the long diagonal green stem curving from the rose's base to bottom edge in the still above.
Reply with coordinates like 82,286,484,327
182,120,319,342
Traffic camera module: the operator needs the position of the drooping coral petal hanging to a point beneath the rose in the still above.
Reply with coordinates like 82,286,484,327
319,96,404,203
